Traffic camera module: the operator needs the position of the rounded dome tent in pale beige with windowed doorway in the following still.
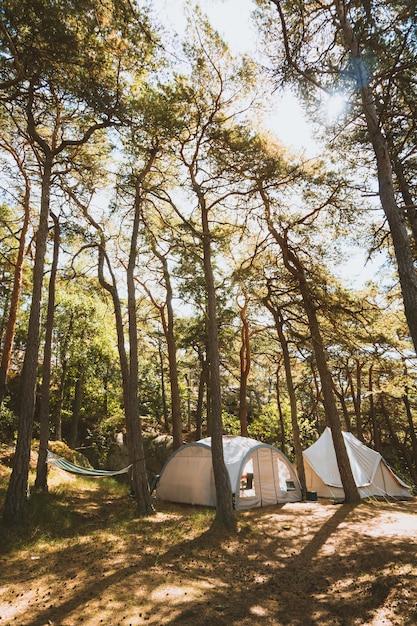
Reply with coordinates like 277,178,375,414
156,436,302,509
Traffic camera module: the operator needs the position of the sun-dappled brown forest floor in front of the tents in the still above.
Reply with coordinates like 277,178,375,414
0,454,417,626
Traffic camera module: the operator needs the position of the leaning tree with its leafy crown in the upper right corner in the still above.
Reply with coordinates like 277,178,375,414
259,0,417,350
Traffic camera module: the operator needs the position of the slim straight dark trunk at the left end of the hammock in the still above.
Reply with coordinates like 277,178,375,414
35,213,61,490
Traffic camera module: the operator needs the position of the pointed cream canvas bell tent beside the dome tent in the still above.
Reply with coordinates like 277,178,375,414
303,427,412,499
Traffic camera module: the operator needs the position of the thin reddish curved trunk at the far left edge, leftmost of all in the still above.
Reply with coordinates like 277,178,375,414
0,155,30,410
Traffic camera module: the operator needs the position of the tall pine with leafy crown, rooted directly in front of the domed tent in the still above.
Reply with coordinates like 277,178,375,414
156,11,260,528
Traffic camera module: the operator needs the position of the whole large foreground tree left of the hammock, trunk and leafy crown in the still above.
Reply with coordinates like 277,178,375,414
0,0,157,525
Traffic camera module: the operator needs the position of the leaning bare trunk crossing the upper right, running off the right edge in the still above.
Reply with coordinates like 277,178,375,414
334,0,417,352
